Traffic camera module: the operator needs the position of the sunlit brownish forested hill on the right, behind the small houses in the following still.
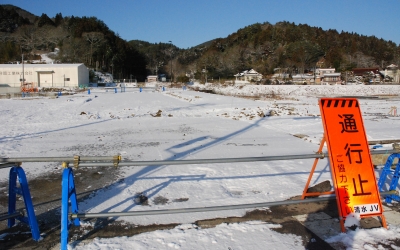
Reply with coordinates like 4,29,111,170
163,22,400,78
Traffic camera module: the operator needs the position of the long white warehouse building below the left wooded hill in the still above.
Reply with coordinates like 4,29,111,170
0,64,89,88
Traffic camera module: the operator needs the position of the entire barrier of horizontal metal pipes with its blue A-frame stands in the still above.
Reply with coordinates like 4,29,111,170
0,149,400,250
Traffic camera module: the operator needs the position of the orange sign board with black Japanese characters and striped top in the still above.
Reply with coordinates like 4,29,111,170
319,98,383,223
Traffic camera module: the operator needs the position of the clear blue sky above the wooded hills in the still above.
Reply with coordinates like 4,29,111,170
0,0,400,48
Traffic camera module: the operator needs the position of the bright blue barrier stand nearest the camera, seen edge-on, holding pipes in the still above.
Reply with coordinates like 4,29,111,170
61,168,80,250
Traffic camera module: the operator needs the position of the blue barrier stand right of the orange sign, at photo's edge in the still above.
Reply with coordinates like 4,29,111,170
378,153,400,203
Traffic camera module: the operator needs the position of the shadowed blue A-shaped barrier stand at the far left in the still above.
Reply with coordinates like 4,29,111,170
8,166,41,241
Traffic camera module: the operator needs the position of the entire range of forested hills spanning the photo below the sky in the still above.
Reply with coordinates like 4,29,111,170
0,5,400,81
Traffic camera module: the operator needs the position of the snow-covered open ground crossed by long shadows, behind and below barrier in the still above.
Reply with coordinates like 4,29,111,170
0,85,400,250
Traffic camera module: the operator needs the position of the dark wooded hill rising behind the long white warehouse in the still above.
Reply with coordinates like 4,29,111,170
0,5,147,81
